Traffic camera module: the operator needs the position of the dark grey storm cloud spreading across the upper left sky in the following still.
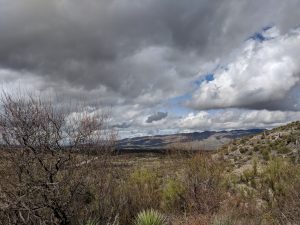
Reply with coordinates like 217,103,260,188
0,0,300,102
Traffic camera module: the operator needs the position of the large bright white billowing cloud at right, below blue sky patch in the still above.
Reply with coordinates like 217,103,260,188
188,27,300,110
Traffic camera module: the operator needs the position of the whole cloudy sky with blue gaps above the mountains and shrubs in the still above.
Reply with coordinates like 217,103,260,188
0,0,300,138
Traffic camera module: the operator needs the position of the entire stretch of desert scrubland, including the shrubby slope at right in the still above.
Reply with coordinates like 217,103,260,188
0,102,300,225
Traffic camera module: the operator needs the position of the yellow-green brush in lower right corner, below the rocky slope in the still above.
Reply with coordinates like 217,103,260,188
218,158,300,225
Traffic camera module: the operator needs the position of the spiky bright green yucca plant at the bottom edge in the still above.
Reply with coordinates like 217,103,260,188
134,209,167,225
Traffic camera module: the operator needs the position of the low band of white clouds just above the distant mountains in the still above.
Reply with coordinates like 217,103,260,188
116,109,300,138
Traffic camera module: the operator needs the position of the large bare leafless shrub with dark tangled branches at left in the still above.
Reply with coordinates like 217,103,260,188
0,93,114,225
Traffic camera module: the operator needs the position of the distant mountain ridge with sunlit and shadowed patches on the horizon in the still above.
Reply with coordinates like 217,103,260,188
117,129,264,150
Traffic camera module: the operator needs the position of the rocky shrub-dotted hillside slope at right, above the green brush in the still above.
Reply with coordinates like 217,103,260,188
218,121,300,172
